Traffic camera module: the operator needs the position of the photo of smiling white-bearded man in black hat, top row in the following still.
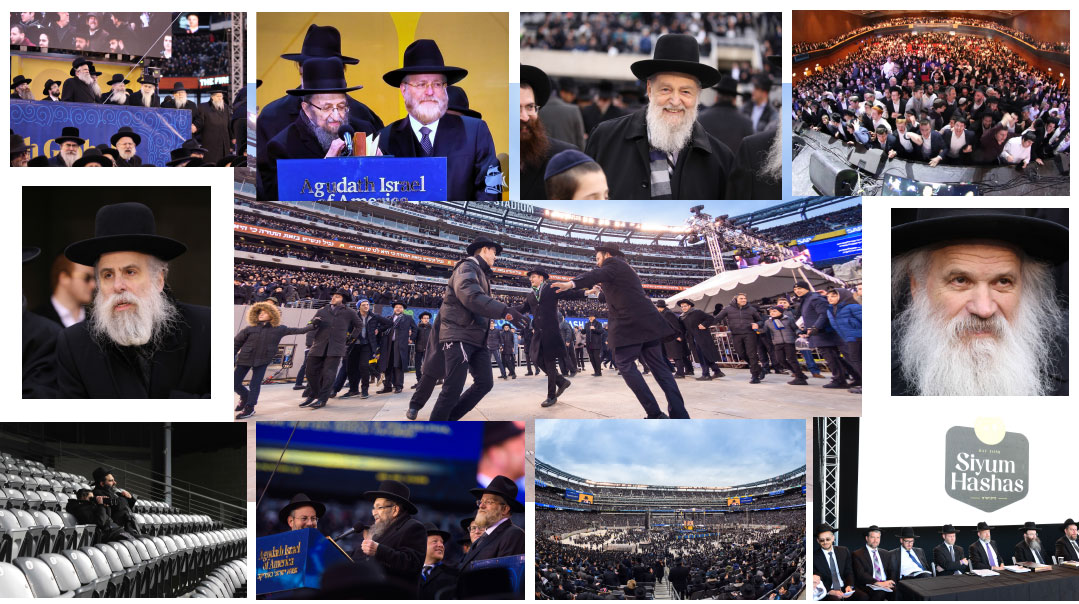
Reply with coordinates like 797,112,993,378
520,12,782,200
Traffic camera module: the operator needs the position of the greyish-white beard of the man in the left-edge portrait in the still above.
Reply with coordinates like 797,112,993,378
87,290,179,346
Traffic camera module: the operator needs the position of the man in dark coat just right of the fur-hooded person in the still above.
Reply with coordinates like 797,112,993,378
300,289,363,409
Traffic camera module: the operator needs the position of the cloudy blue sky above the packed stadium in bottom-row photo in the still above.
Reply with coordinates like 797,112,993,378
535,420,806,486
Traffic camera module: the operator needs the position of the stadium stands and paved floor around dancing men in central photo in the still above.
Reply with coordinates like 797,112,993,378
234,193,861,421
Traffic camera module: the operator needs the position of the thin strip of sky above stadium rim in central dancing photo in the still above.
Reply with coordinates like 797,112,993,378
534,197,860,228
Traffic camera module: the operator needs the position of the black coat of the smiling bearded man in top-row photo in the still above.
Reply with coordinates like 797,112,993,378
585,108,735,200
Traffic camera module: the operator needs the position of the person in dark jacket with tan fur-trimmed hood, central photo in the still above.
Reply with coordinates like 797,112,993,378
233,302,323,420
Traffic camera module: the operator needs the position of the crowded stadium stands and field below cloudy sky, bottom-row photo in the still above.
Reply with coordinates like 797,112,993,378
535,458,806,600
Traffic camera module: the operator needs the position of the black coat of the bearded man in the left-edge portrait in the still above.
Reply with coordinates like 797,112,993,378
56,302,210,398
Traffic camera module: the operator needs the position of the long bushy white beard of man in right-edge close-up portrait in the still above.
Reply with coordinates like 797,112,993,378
892,251,1067,396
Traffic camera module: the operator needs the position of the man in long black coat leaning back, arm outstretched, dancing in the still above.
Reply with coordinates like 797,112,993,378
551,243,689,420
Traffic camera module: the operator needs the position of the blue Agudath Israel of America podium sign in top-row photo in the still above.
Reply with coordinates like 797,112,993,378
277,156,446,202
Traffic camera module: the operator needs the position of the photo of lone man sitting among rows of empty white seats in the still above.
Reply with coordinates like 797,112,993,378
0,424,247,599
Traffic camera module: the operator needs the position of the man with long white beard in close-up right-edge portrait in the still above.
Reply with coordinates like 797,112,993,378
891,208,1068,396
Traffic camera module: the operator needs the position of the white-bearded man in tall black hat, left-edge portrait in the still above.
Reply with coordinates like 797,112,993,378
56,202,209,398
